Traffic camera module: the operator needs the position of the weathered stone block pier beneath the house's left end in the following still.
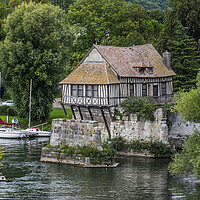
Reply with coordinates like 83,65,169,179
50,119,101,146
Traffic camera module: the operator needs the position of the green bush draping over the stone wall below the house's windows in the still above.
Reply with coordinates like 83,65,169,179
121,96,156,121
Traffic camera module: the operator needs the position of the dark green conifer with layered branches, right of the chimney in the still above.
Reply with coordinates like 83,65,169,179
167,23,200,91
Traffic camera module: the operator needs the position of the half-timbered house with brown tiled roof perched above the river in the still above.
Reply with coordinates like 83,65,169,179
60,44,175,134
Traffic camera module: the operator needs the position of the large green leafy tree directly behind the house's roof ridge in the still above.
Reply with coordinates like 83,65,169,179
67,0,162,71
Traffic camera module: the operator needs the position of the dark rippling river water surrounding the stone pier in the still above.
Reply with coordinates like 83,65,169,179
0,138,200,200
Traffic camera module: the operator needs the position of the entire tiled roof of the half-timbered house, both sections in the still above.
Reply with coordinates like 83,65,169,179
60,44,175,84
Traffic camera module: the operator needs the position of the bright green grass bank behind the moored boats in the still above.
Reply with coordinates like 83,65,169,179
0,108,72,130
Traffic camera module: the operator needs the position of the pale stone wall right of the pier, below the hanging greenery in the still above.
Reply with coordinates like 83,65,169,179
111,108,168,144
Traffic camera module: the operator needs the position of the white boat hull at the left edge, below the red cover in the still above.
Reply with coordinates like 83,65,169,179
0,128,27,139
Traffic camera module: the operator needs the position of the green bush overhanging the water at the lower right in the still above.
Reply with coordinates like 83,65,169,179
168,131,200,176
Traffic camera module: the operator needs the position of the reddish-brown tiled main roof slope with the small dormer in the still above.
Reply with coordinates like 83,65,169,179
94,44,175,77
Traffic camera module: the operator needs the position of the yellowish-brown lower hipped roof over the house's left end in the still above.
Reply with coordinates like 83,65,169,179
60,62,119,85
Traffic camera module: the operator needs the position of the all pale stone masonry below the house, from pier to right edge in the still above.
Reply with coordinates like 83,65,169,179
50,108,200,146
